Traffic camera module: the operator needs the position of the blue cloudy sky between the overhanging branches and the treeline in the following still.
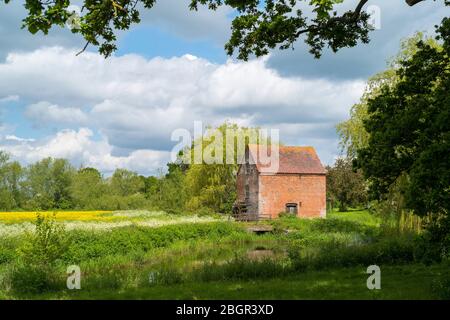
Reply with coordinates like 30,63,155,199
0,0,449,175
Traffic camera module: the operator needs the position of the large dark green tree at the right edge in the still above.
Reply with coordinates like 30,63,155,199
355,18,450,218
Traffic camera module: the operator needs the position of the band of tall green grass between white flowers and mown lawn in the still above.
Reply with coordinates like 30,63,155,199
0,212,445,295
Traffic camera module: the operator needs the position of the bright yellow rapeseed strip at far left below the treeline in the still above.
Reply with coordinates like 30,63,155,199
0,211,115,223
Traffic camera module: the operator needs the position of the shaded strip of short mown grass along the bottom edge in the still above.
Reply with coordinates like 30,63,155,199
35,265,447,300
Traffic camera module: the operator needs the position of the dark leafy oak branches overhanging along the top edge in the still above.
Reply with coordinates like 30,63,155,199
4,0,450,60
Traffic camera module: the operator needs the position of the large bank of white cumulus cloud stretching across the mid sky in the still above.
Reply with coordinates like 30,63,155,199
0,47,364,168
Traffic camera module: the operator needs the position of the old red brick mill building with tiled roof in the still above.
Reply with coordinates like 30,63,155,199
237,145,326,218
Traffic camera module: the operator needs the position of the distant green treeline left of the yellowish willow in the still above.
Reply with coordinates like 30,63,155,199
0,151,190,211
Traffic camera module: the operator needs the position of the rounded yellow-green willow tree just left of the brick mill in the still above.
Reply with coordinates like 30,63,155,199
181,122,271,213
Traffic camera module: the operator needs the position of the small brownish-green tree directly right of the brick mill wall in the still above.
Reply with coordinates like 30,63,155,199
327,158,367,211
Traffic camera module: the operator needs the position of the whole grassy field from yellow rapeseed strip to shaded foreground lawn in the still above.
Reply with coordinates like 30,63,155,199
0,210,449,299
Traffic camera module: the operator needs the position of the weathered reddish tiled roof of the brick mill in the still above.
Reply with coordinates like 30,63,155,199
249,145,326,174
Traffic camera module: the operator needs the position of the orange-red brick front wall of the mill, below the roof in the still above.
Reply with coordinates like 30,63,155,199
259,174,326,218
